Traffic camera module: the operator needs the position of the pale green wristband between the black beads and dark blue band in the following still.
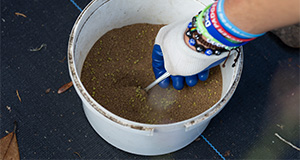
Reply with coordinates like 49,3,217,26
196,5,232,50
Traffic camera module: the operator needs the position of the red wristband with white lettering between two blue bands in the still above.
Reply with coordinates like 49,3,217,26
210,2,255,43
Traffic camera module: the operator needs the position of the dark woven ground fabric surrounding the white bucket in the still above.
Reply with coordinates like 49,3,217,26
0,0,300,159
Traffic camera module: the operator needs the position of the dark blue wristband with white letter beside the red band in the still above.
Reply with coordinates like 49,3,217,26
204,9,248,47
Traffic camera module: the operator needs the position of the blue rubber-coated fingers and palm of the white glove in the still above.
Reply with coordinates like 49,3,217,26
152,44,226,90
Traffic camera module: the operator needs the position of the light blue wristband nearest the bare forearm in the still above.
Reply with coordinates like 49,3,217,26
217,0,265,39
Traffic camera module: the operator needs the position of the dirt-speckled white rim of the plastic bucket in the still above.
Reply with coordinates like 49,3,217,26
67,0,243,131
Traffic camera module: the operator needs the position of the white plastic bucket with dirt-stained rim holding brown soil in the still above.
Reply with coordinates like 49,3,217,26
68,0,243,155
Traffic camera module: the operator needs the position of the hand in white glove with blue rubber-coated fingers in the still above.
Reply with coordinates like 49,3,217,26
152,21,228,90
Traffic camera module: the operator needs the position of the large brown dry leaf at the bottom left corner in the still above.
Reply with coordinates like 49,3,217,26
0,122,20,160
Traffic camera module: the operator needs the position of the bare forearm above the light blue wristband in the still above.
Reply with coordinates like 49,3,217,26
224,0,300,34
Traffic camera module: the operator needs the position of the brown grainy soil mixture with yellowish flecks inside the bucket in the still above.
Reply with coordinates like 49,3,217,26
81,24,222,124
